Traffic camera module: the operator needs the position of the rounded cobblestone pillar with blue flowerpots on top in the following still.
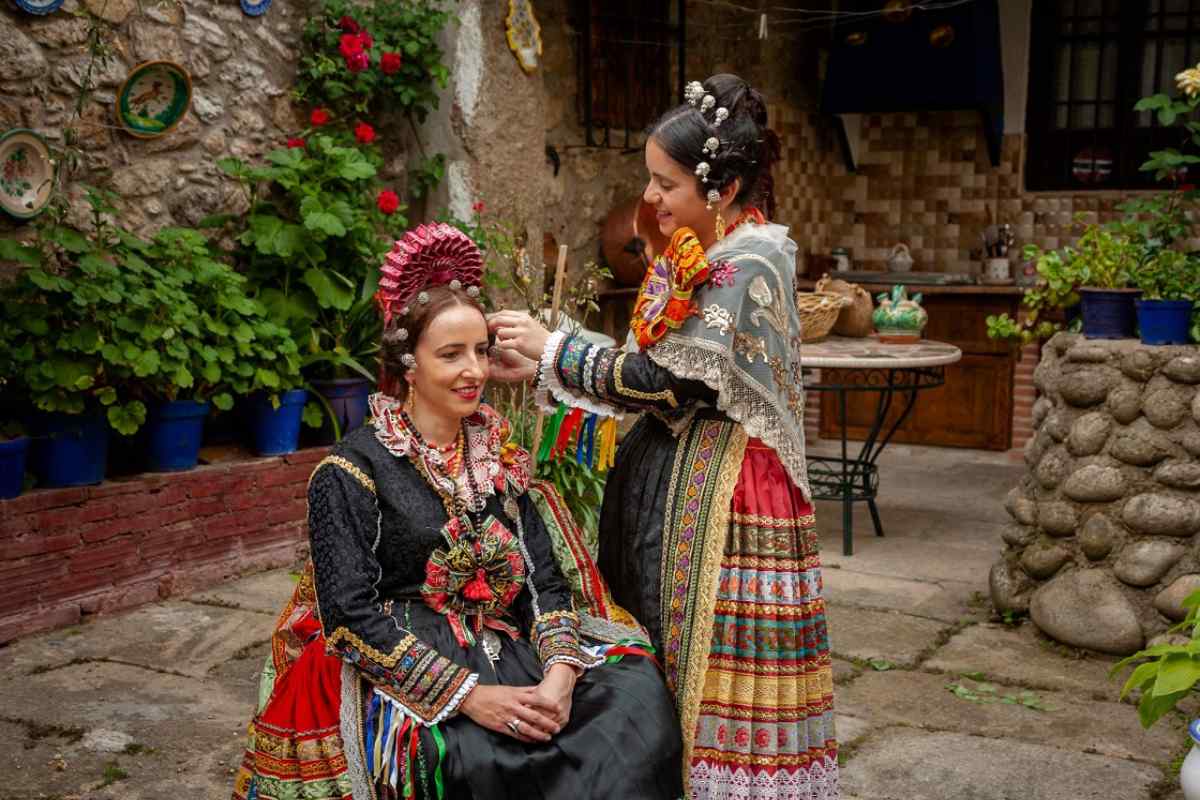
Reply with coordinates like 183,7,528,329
990,333,1200,654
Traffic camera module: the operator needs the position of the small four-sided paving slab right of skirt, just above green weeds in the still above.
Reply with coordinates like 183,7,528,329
827,603,948,667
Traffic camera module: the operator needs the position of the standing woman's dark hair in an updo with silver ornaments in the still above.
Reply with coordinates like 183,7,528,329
650,73,780,218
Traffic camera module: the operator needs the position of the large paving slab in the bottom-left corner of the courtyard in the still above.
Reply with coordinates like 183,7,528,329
0,661,258,800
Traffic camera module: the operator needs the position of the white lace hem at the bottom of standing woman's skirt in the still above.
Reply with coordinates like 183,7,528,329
689,756,840,800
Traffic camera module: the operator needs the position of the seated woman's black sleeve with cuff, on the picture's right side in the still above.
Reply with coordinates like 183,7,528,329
505,494,599,669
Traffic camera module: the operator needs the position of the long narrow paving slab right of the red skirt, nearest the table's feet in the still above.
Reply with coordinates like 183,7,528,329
823,567,973,622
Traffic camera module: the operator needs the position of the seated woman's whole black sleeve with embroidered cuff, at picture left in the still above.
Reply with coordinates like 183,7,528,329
308,456,478,724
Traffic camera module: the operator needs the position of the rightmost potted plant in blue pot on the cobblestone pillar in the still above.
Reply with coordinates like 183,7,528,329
1134,249,1200,344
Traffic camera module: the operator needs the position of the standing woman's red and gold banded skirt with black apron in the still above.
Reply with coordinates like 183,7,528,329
599,415,839,800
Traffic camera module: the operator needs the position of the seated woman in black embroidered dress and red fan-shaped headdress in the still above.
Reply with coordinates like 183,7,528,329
234,224,682,800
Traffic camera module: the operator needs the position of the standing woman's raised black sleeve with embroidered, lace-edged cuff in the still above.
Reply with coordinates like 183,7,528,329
541,336,716,411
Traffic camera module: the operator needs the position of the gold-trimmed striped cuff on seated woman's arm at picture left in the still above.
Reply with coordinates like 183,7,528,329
328,628,479,726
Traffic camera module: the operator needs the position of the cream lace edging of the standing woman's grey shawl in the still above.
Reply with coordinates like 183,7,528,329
646,333,812,503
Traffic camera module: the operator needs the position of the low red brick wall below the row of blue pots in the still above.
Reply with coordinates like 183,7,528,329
0,447,329,644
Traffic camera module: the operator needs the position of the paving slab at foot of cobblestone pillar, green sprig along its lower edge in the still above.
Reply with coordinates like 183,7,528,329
924,624,1122,700
